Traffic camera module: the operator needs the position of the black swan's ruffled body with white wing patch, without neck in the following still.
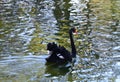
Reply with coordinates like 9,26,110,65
46,42,72,62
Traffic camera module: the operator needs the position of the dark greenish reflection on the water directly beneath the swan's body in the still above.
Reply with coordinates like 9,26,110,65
45,63,72,77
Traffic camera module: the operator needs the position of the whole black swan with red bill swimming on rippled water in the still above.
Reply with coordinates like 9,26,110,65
46,28,76,63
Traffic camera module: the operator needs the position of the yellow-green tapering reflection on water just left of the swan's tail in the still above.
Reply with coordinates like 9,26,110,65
28,23,46,55
